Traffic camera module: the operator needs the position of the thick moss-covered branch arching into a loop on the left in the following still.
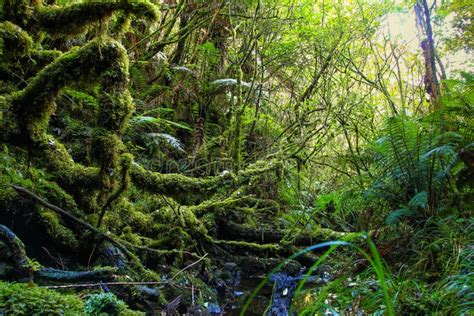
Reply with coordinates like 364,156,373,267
5,39,132,198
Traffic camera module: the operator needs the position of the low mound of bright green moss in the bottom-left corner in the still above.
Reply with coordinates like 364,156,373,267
0,282,83,315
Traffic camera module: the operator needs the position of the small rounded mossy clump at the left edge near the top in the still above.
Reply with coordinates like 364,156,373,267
0,22,33,62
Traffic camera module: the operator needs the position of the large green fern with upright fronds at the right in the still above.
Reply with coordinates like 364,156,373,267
367,112,464,224
